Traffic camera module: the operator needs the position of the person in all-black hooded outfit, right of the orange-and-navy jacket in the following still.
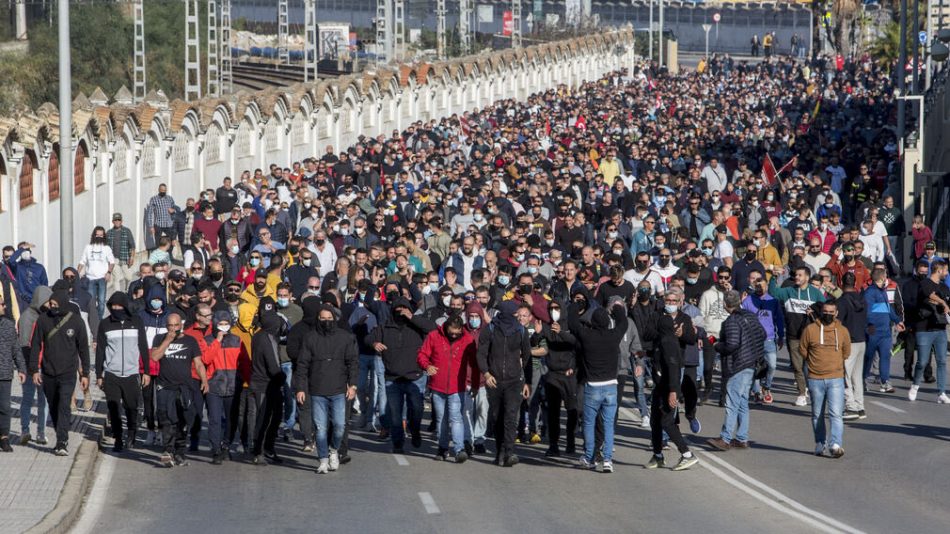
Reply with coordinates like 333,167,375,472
248,297,287,464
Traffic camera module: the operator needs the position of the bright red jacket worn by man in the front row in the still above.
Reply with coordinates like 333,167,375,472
416,325,478,395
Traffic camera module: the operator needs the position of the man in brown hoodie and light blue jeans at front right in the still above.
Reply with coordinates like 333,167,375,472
801,300,860,458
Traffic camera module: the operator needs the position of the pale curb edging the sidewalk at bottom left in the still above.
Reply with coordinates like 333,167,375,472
26,439,99,534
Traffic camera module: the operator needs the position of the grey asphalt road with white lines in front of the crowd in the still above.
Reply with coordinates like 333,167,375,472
75,357,950,533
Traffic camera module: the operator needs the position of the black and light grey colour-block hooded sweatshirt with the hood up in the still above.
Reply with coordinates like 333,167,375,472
96,292,149,378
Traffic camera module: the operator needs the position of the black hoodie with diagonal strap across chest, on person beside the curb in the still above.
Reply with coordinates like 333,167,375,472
29,291,89,377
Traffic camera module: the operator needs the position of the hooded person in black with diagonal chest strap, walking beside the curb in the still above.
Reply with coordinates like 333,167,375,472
28,291,89,456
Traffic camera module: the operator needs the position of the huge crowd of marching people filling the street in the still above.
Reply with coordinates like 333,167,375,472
0,51,950,473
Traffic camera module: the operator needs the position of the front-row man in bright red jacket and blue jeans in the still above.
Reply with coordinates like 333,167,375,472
418,313,478,464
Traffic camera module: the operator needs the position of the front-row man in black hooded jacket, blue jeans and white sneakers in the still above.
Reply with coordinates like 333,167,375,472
294,304,359,474
